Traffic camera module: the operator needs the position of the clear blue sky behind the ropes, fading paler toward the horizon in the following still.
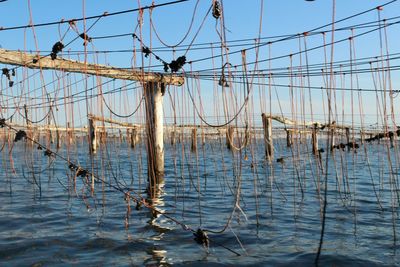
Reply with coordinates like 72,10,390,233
0,0,400,129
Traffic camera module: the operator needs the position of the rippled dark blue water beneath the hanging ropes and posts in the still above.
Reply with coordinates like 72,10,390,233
0,139,400,266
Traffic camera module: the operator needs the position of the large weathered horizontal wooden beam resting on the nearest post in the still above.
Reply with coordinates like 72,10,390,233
0,49,185,86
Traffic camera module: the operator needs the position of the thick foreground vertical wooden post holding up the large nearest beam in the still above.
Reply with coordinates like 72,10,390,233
144,82,165,197
